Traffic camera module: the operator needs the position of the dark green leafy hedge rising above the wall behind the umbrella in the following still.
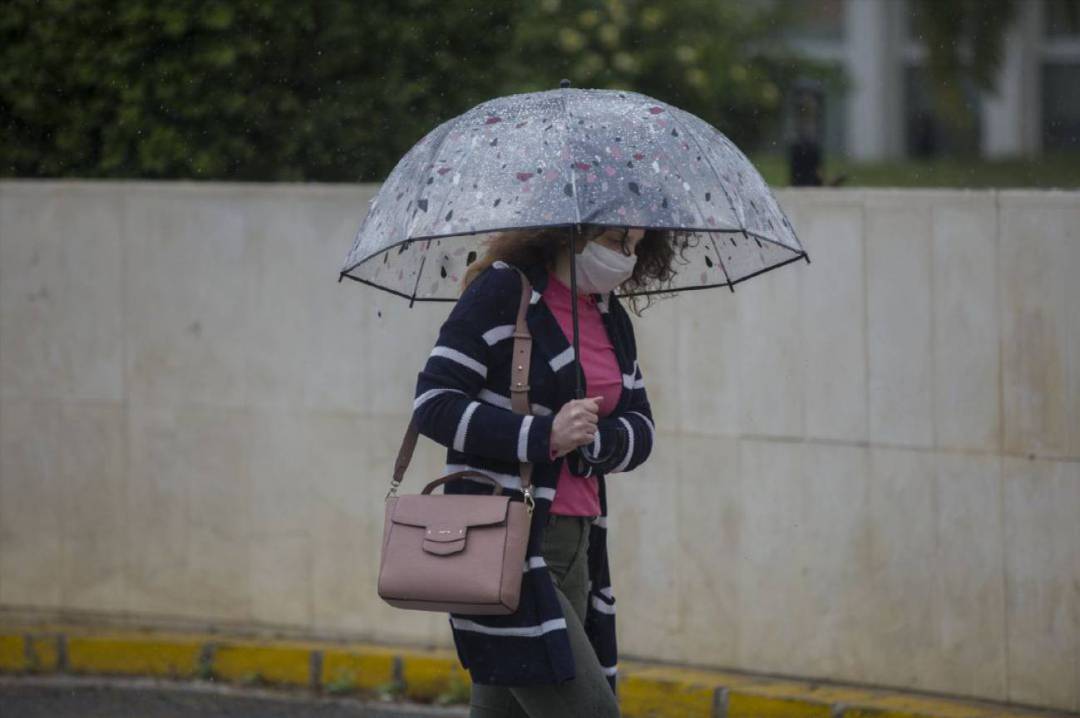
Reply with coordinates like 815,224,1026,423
0,0,797,181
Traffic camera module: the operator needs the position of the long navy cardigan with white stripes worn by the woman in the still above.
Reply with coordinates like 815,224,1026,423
413,261,654,691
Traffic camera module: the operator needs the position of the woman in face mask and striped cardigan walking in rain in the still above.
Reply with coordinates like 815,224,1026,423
414,227,673,718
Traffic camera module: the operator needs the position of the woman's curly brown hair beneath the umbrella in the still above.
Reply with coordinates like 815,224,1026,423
461,225,678,316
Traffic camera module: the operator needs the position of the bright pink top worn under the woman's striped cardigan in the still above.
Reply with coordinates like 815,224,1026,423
542,272,622,516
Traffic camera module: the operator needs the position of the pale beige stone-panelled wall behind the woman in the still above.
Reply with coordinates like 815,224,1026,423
0,181,1080,709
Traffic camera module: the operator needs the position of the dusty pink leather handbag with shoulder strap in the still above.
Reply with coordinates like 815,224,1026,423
378,265,534,615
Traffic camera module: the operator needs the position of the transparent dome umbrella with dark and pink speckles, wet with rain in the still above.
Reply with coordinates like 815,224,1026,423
338,80,810,397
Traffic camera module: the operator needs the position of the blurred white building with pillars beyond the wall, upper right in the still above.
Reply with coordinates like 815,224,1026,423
788,0,1080,160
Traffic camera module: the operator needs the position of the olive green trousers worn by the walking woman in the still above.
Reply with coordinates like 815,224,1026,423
469,514,619,718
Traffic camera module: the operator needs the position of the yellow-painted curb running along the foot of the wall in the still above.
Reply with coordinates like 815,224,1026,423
0,624,1080,718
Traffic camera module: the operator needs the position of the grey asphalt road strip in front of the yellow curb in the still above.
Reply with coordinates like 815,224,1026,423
0,676,468,718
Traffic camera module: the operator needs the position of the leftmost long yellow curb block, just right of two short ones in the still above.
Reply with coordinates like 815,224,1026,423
67,636,200,678
